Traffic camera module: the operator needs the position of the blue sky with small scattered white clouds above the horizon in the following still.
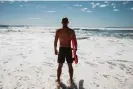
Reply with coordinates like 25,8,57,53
0,0,133,28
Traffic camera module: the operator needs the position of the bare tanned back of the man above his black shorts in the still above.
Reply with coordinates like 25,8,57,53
57,28,74,47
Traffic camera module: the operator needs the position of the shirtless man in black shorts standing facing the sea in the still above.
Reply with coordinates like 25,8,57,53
54,18,77,85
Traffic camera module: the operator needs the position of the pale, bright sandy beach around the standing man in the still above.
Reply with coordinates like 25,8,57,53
0,30,133,89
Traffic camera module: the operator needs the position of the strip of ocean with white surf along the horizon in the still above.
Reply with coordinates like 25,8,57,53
0,26,133,39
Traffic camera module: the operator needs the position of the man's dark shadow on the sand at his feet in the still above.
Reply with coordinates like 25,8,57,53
60,80,85,89
